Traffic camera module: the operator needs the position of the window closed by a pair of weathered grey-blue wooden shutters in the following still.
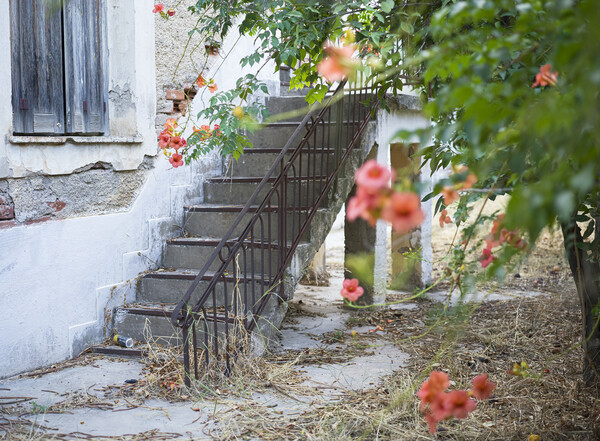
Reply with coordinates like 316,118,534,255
10,0,108,135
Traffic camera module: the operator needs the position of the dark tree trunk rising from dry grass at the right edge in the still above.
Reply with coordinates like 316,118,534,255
561,218,600,385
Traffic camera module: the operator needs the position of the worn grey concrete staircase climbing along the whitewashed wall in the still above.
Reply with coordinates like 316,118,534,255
106,96,371,354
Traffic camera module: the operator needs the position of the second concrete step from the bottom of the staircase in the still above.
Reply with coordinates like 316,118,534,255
137,269,269,311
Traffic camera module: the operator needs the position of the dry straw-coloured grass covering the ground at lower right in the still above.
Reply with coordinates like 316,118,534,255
203,293,600,441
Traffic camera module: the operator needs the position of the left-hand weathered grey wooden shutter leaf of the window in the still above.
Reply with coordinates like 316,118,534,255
10,0,65,134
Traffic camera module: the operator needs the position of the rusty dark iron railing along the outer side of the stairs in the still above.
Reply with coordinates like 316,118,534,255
171,82,378,385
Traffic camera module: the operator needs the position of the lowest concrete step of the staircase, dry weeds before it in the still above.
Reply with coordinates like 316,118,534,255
113,303,236,347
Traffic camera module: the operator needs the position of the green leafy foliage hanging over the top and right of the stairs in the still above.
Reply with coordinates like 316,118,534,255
190,0,600,258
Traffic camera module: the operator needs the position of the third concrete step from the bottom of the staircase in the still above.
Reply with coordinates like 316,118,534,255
164,237,288,274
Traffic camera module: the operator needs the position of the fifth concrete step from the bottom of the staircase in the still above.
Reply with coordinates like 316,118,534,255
204,176,325,207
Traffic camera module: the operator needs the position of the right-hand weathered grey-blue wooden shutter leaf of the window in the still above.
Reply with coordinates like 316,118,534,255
63,0,107,134
